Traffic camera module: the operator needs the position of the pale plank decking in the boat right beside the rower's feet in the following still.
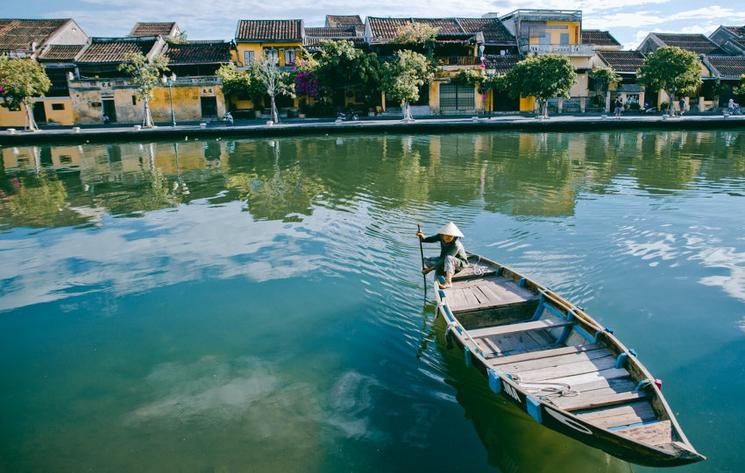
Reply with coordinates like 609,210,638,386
445,275,535,312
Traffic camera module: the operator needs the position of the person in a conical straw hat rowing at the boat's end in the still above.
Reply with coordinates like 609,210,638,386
416,222,468,289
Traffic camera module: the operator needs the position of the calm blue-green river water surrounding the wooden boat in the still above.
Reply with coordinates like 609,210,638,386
0,131,745,473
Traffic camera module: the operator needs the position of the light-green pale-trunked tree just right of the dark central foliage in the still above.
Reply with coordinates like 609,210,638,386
383,49,434,120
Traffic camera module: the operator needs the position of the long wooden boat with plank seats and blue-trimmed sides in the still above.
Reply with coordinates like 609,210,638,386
435,255,706,467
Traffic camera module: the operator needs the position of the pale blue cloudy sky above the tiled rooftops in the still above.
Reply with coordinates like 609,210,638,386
1,0,745,49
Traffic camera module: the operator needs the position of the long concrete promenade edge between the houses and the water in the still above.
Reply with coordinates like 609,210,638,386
0,115,745,146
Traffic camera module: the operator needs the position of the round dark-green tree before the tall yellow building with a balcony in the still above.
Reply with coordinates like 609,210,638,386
507,54,577,118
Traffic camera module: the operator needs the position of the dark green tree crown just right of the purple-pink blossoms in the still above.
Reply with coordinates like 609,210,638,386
301,41,381,103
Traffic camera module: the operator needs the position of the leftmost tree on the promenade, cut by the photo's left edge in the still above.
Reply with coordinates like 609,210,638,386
0,55,52,131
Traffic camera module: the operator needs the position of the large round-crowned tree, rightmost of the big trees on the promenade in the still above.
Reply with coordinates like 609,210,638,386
638,47,702,116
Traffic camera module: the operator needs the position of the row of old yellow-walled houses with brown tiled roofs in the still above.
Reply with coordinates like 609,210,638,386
0,10,745,127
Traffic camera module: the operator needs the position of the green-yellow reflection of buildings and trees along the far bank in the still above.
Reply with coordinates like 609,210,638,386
2,130,745,228
